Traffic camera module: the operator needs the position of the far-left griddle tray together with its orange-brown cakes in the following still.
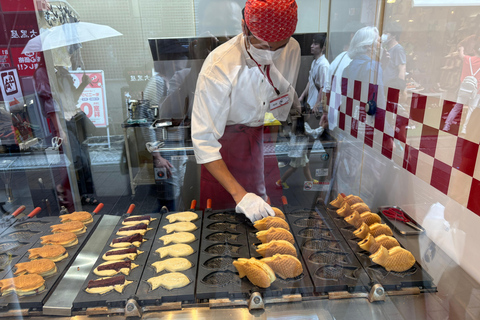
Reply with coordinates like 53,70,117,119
0,205,103,310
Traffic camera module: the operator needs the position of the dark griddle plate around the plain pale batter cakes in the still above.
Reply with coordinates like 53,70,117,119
136,211,202,306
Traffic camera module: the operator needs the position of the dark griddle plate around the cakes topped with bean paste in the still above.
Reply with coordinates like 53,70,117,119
73,214,161,310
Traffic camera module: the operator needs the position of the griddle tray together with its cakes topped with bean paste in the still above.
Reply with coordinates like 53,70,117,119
73,205,161,310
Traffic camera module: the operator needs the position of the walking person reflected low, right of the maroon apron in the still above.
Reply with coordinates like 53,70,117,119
276,113,327,189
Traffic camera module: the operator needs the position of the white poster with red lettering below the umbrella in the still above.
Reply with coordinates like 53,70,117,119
70,70,108,128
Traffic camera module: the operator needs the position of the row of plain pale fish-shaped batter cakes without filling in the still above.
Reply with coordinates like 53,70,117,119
147,211,198,290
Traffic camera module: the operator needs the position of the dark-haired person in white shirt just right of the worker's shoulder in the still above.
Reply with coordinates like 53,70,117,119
299,34,330,114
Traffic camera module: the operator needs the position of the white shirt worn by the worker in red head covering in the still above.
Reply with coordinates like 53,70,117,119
192,34,300,164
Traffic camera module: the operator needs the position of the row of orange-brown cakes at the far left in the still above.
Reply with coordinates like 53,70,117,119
0,211,93,296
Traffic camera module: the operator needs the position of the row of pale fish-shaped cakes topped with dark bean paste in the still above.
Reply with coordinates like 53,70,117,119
85,215,156,294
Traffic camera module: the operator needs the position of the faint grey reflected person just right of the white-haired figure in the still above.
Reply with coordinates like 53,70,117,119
382,22,407,87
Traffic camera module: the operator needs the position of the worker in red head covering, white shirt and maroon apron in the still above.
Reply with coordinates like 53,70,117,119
192,0,300,222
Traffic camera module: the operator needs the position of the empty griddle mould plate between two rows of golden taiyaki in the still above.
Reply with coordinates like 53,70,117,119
285,206,369,293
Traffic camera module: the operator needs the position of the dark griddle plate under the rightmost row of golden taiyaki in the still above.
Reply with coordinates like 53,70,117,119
318,206,434,290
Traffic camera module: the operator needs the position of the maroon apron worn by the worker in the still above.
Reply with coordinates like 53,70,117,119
200,124,266,210
